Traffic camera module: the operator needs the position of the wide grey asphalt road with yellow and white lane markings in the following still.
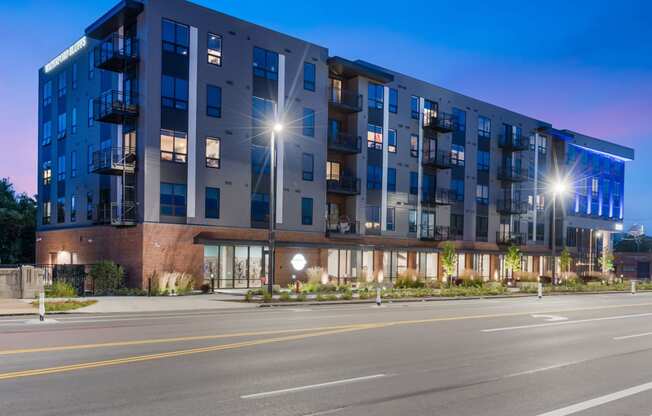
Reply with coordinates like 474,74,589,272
0,294,652,416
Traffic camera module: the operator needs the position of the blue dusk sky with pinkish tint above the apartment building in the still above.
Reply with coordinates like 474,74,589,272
0,0,652,230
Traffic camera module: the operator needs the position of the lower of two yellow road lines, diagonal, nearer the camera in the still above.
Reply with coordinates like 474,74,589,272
0,324,379,381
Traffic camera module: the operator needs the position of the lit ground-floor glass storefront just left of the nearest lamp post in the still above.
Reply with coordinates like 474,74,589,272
204,245,268,289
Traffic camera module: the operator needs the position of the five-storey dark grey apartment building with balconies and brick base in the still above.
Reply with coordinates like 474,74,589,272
37,0,634,288
